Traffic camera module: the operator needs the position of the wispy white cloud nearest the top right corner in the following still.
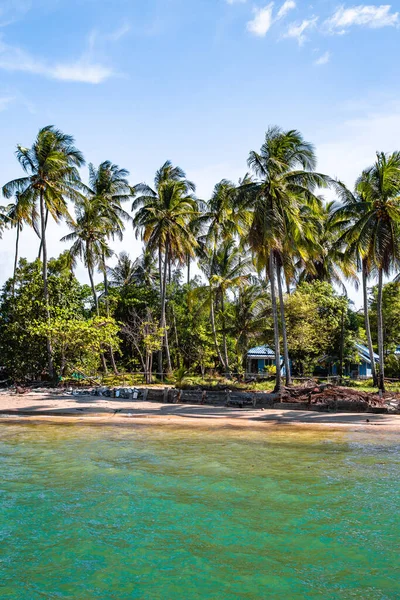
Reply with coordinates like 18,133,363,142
325,4,399,34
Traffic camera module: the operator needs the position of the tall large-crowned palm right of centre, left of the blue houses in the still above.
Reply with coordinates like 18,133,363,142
242,127,328,393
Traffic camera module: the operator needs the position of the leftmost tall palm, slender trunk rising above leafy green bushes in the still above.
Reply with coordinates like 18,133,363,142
3,125,84,377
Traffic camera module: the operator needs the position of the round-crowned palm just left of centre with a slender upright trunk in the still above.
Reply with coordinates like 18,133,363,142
132,161,198,373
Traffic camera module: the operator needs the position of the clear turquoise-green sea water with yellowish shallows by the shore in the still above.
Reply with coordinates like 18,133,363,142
0,424,400,600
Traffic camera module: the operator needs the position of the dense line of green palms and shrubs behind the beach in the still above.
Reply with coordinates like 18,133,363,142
0,126,400,391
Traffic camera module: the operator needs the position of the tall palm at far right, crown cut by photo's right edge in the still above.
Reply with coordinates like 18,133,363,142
332,152,400,392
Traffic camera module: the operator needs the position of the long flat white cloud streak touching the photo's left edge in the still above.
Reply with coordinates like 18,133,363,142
0,40,113,84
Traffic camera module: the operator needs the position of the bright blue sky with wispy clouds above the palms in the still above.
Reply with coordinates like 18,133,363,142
0,0,400,302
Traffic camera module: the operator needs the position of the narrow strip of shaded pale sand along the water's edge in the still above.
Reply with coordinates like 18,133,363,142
0,392,400,431
